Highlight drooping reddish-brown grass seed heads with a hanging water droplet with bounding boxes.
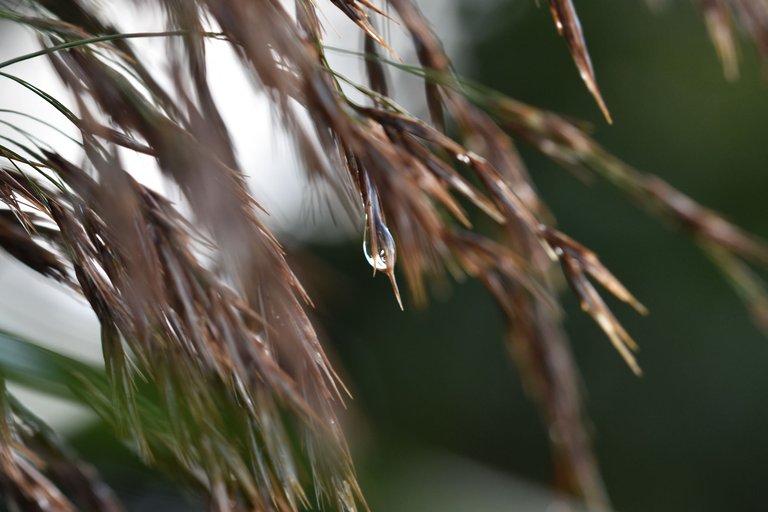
[0,0,768,512]
